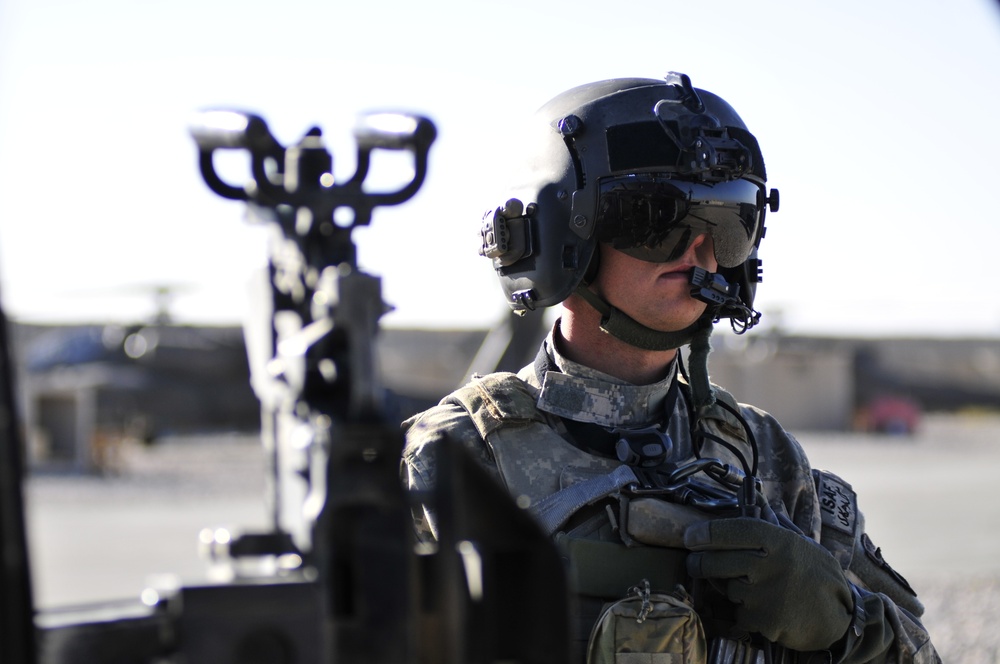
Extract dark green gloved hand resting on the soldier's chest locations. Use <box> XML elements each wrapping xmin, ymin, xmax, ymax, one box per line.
<box><xmin>684</xmin><ymin>517</ymin><xmax>854</xmax><ymax>652</ymax></box>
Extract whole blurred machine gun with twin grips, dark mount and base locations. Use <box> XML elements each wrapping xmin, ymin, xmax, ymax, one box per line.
<box><xmin>0</xmin><ymin>111</ymin><xmax>568</xmax><ymax>664</ymax></box>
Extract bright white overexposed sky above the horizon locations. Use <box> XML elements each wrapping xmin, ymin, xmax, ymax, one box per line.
<box><xmin>0</xmin><ymin>0</ymin><xmax>1000</xmax><ymax>337</ymax></box>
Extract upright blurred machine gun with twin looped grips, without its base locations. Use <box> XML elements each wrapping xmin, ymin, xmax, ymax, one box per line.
<box><xmin>191</xmin><ymin>106</ymin><xmax>436</xmax><ymax>661</ymax></box>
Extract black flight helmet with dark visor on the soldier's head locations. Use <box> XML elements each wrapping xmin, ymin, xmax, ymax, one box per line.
<box><xmin>480</xmin><ymin>73</ymin><xmax>778</xmax><ymax>342</ymax></box>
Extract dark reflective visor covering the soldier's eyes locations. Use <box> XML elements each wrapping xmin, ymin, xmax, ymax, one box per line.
<box><xmin>597</xmin><ymin>179</ymin><xmax>764</xmax><ymax>267</ymax></box>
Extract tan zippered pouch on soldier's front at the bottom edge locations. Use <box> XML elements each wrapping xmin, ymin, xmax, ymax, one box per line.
<box><xmin>587</xmin><ymin>580</ymin><xmax>708</xmax><ymax>664</ymax></box>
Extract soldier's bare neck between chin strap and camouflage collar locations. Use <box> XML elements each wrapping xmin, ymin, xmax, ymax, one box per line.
<box><xmin>559</xmin><ymin>301</ymin><xmax>677</xmax><ymax>385</ymax></box>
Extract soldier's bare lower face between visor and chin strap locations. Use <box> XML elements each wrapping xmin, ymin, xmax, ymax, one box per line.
<box><xmin>591</xmin><ymin>235</ymin><xmax>719</xmax><ymax>332</ymax></box>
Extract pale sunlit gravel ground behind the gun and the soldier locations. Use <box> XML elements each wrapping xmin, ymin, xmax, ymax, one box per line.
<box><xmin>26</xmin><ymin>416</ymin><xmax>1000</xmax><ymax>664</ymax></box>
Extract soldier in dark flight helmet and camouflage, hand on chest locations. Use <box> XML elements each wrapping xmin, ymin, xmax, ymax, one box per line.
<box><xmin>401</xmin><ymin>73</ymin><xmax>939</xmax><ymax>662</ymax></box>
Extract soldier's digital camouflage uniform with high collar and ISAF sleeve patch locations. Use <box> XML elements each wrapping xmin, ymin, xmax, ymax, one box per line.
<box><xmin>401</xmin><ymin>323</ymin><xmax>939</xmax><ymax>662</ymax></box>
